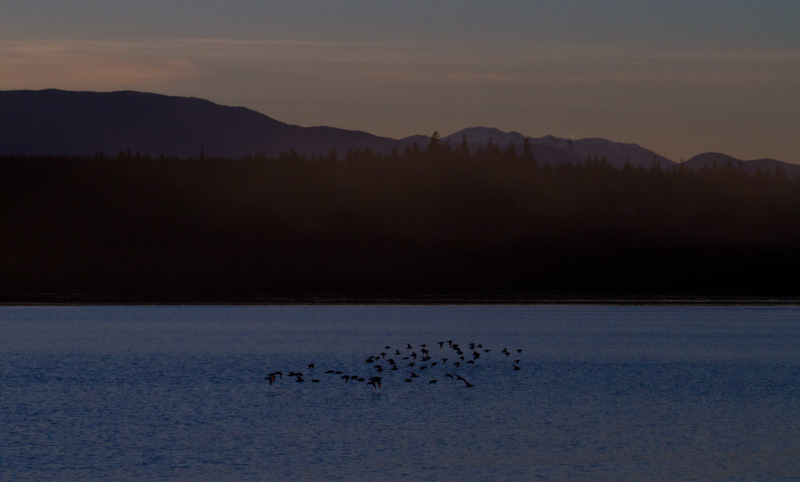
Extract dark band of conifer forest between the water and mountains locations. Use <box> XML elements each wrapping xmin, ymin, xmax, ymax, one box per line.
<box><xmin>0</xmin><ymin>135</ymin><xmax>800</xmax><ymax>301</ymax></box>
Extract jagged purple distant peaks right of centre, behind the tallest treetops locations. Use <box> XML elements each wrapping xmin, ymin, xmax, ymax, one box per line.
<box><xmin>442</xmin><ymin>127</ymin><xmax>674</xmax><ymax>168</ymax></box>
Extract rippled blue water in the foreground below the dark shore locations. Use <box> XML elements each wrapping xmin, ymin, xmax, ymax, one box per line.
<box><xmin>0</xmin><ymin>306</ymin><xmax>800</xmax><ymax>481</ymax></box>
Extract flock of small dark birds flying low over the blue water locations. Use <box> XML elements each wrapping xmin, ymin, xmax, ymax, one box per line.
<box><xmin>264</xmin><ymin>340</ymin><xmax>522</xmax><ymax>390</ymax></box>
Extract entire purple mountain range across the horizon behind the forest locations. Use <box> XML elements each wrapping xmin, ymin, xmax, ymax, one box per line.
<box><xmin>0</xmin><ymin>89</ymin><xmax>800</xmax><ymax>176</ymax></box>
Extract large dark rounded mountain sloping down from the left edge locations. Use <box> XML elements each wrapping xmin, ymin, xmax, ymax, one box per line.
<box><xmin>0</xmin><ymin>90</ymin><xmax>398</xmax><ymax>158</ymax></box>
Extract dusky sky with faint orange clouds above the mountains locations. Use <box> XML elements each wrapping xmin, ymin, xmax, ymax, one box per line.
<box><xmin>0</xmin><ymin>0</ymin><xmax>800</xmax><ymax>163</ymax></box>
